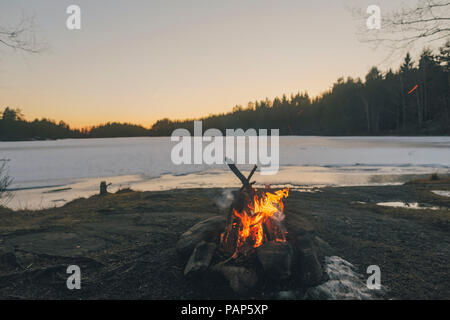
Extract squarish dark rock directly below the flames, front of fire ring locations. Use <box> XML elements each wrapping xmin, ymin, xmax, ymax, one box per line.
<box><xmin>256</xmin><ymin>241</ymin><xmax>293</xmax><ymax>281</ymax></box>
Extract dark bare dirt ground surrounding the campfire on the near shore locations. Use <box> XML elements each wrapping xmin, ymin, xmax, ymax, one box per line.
<box><xmin>0</xmin><ymin>179</ymin><xmax>450</xmax><ymax>299</ymax></box>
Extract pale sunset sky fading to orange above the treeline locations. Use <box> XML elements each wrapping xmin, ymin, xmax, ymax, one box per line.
<box><xmin>0</xmin><ymin>0</ymin><xmax>436</xmax><ymax>127</ymax></box>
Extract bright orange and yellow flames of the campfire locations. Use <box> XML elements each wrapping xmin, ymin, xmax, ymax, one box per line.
<box><xmin>233</xmin><ymin>188</ymin><xmax>289</xmax><ymax>254</ymax></box>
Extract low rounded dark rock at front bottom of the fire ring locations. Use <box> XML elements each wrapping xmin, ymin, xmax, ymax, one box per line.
<box><xmin>212</xmin><ymin>263</ymin><xmax>258</xmax><ymax>295</ymax></box>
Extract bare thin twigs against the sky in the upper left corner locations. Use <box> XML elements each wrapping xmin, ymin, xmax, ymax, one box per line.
<box><xmin>0</xmin><ymin>17</ymin><xmax>46</xmax><ymax>53</ymax></box>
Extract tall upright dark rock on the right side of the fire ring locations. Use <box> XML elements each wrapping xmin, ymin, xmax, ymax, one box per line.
<box><xmin>297</xmin><ymin>233</ymin><xmax>323</xmax><ymax>287</ymax></box>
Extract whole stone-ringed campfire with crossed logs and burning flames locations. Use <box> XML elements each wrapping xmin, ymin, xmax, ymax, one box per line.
<box><xmin>177</xmin><ymin>164</ymin><xmax>331</xmax><ymax>295</ymax></box>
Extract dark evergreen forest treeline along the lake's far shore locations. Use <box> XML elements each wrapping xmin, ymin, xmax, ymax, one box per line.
<box><xmin>0</xmin><ymin>42</ymin><xmax>450</xmax><ymax>140</ymax></box>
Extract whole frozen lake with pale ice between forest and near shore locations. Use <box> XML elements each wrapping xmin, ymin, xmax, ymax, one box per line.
<box><xmin>0</xmin><ymin>137</ymin><xmax>450</xmax><ymax>209</ymax></box>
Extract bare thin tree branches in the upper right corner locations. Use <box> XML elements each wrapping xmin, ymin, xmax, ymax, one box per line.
<box><xmin>352</xmin><ymin>0</ymin><xmax>450</xmax><ymax>52</ymax></box>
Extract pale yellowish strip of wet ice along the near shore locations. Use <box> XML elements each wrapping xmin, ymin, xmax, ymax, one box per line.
<box><xmin>5</xmin><ymin>166</ymin><xmax>450</xmax><ymax>210</ymax></box>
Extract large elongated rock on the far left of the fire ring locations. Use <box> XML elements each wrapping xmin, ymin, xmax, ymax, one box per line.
<box><xmin>177</xmin><ymin>216</ymin><xmax>226</xmax><ymax>257</ymax></box>
